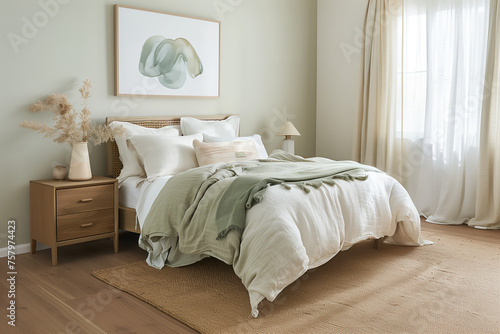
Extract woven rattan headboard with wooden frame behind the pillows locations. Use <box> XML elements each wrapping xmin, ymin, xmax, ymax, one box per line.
<box><xmin>106</xmin><ymin>115</ymin><xmax>233</xmax><ymax>178</ymax></box>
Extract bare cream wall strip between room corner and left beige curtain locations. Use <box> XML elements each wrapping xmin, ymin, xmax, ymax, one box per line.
<box><xmin>316</xmin><ymin>0</ymin><xmax>368</xmax><ymax>160</ymax></box>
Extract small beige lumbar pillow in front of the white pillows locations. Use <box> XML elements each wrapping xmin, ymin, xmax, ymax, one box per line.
<box><xmin>193</xmin><ymin>139</ymin><xmax>259</xmax><ymax>166</ymax></box>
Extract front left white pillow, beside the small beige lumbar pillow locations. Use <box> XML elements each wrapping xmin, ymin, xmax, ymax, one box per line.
<box><xmin>128</xmin><ymin>134</ymin><xmax>203</xmax><ymax>179</ymax></box>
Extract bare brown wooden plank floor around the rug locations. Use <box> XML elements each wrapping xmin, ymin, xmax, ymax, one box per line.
<box><xmin>0</xmin><ymin>222</ymin><xmax>500</xmax><ymax>334</ymax></box>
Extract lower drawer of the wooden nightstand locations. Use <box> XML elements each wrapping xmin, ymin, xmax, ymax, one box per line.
<box><xmin>57</xmin><ymin>209</ymin><xmax>115</xmax><ymax>241</ymax></box>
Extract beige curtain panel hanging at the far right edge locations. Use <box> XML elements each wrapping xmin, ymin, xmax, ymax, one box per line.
<box><xmin>469</xmin><ymin>0</ymin><xmax>500</xmax><ymax>229</ymax></box>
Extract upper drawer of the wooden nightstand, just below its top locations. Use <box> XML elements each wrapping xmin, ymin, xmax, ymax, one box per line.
<box><xmin>57</xmin><ymin>184</ymin><xmax>114</xmax><ymax>215</ymax></box>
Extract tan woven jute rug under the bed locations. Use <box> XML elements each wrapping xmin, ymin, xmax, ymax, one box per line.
<box><xmin>93</xmin><ymin>232</ymin><xmax>500</xmax><ymax>333</ymax></box>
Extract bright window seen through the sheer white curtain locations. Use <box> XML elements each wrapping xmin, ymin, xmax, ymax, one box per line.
<box><xmin>396</xmin><ymin>0</ymin><xmax>489</xmax><ymax>165</ymax></box>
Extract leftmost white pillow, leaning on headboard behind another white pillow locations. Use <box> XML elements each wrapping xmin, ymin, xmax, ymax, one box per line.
<box><xmin>109</xmin><ymin>121</ymin><xmax>180</xmax><ymax>184</ymax></box>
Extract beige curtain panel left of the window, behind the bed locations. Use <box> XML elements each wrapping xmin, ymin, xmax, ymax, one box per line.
<box><xmin>353</xmin><ymin>0</ymin><xmax>402</xmax><ymax>181</ymax></box>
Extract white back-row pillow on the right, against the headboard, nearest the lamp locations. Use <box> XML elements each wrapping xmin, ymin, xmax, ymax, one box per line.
<box><xmin>181</xmin><ymin>116</ymin><xmax>240</xmax><ymax>137</ymax></box>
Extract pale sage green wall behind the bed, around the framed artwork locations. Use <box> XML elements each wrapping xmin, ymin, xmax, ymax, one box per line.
<box><xmin>0</xmin><ymin>0</ymin><xmax>317</xmax><ymax>248</ymax></box>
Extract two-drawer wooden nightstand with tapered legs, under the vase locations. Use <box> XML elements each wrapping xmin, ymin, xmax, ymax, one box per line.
<box><xmin>30</xmin><ymin>176</ymin><xmax>118</xmax><ymax>266</ymax></box>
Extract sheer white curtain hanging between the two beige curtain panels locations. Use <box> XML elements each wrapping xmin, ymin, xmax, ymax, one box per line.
<box><xmin>397</xmin><ymin>0</ymin><xmax>490</xmax><ymax>224</ymax></box>
